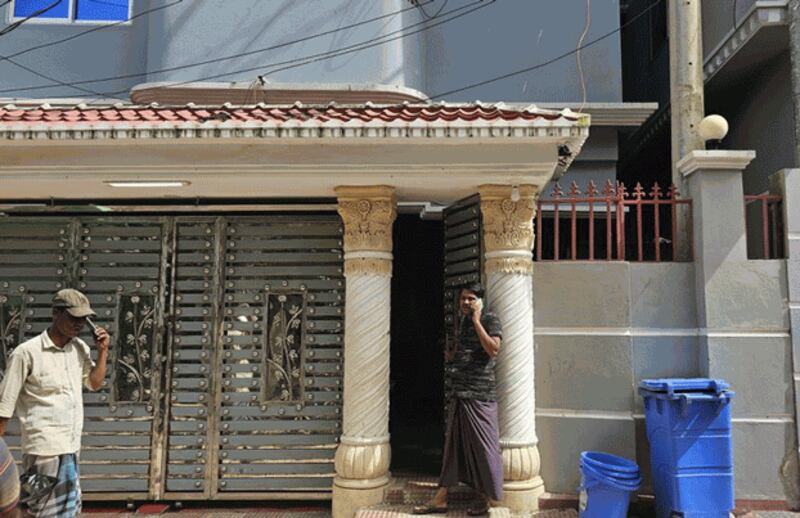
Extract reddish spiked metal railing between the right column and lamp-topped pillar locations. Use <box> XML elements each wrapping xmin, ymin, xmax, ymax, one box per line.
<box><xmin>534</xmin><ymin>180</ymin><xmax>692</xmax><ymax>262</ymax></box>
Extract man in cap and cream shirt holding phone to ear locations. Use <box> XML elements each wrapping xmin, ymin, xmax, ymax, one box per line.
<box><xmin>0</xmin><ymin>289</ymin><xmax>109</xmax><ymax>518</ymax></box>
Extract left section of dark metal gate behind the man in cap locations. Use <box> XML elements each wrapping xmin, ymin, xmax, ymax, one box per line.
<box><xmin>0</xmin><ymin>216</ymin><xmax>170</xmax><ymax>498</ymax></box>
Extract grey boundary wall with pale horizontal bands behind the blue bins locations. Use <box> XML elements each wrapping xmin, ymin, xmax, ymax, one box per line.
<box><xmin>534</xmin><ymin>261</ymin><xmax>793</xmax><ymax>499</ymax></box>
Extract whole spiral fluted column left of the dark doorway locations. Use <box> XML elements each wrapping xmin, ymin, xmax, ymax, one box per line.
<box><xmin>333</xmin><ymin>186</ymin><xmax>396</xmax><ymax>518</ymax></box>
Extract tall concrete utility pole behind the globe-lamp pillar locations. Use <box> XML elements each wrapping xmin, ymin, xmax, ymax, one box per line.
<box><xmin>662</xmin><ymin>0</ymin><xmax>705</xmax><ymax>260</ymax></box>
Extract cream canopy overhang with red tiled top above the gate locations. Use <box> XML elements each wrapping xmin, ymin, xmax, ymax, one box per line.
<box><xmin>0</xmin><ymin>104</ymin><xmax>589</xmax><ymax>204</ymax></box>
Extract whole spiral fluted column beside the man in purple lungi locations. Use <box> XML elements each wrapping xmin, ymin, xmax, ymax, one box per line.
<box><xmin>480</xmin><ymin>185</ymin><xmax>544</xmax><ymax>512</ymax></box>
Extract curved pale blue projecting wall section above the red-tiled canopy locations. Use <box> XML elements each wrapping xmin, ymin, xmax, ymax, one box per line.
<box><xmin>142</xmin><ymin>0</ymin><xmax>424</xmax><ymax>92</ymax></box>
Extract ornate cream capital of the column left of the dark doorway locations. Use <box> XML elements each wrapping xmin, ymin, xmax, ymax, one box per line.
<box><xmin>336</xmin><ymin>185</ymin><xmax>397</xmax><ymax>276</ymax></box>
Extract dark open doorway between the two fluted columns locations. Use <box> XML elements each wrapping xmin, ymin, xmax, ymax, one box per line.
<box><xmin>389</xmin><ymin>215</ymin><xmax>444</xmax><ymax>475</ymax></box>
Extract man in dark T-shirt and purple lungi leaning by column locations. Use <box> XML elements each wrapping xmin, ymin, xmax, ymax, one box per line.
<box><xmin>414</xmin><ymin>284</ymin><xmax>503</xmax><ymax>516</ymax></box>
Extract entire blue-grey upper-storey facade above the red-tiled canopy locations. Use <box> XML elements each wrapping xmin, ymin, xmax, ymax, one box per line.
<box><xmin>0</xmin><ymin>0</ymin><xmax>622</xmax><ymax>102</ymax></box>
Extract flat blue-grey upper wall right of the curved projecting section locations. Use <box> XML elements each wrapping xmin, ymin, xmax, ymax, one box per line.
<box><xmin>423</xmin><ymin>0</ymin><xmax>622</xmax><ymax>102</ymax></box>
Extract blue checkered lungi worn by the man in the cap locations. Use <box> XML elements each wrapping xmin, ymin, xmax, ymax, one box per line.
<box><xmin>20</xmin><ymin>453</ymin><xmax>81</xmax><ymax>518</ymax></box>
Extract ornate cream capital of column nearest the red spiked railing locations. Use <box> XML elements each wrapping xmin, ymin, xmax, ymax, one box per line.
<box><xmin>478</xmin><ymin>185</ymin><xmax>539</xmax><ymax>275</ymax></box>
